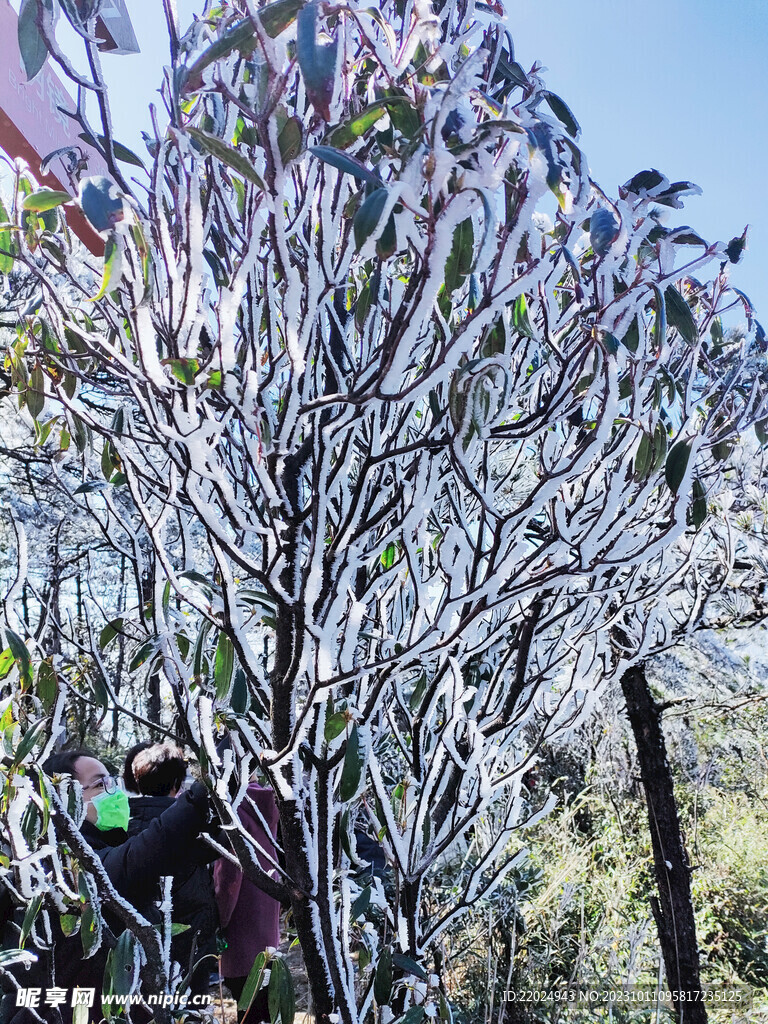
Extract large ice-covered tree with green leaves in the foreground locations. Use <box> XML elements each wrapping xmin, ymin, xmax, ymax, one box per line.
<box><xmin>3</xmin><ymin>0</ymin><xmax>766</xmax><ymax>1024</ymax></box>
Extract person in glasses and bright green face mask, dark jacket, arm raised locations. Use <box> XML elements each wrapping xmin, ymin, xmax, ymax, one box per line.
<box><xmin>0</xmin><ymin>750</ymin><xmax>217</xmax><ymax>1024</ymax></box>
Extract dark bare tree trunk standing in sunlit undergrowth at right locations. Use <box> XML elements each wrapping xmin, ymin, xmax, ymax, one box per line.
<box><xmin>622</xmin><ymin>666</ymin><xmax>707</xmax><ymax>1024</ymax></box>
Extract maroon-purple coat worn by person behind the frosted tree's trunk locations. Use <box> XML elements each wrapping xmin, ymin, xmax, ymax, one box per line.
<box><xmin>213</xmin><ymin>782</ymin><xmax>280</xmax><ymax>978</ymax></box>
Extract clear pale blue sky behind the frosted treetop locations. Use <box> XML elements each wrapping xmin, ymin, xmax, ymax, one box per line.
<box><xmin>94</xmin><ymin>0</ymin><xmax>768</xmax><ymax>311</ymax></box>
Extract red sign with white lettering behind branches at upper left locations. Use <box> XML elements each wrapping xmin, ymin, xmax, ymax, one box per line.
<box><xmin>0</xmin><ymin>0</ymin><xmax>109</xmax><ymax>255</ymax></box>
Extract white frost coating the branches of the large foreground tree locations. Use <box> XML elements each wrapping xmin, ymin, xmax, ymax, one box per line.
<box><xmin>3</xmin><ymin>0</ymin><xmax>765</xmax><ymax>1024</ymax></box>
